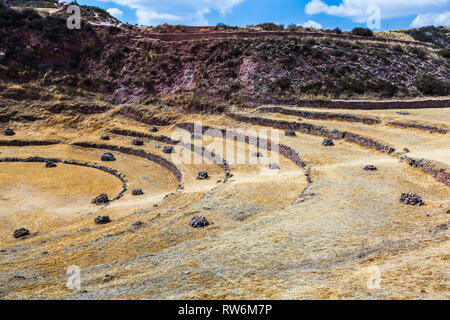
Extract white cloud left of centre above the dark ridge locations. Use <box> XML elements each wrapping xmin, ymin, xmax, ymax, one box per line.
<box><xmin>101</xmin><ymin>0</ymin><xmax>245</xmax><ymax>25</ymax></box>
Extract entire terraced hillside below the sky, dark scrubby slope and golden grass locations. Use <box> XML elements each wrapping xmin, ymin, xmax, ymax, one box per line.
<box><xmin>0</xmin><ymin>1</ymin><xmax>450</xmax><ymax>299</ymax></box>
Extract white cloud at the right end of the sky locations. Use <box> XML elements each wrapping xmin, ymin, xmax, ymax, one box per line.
<box><xmin>305</xmin><ymin>0</ymin><xmax>450</xmax><ymax>23</ymax></box>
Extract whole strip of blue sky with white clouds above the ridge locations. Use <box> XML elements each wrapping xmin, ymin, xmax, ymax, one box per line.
<box><xmin>78</xmin><ymin>0</ymin><xmax>450</xmax><ymax>30</ymax></box>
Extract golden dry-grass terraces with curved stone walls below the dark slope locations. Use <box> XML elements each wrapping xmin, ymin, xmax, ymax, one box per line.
<box><xmin>0</xmin><ymin>101</ymin><xmax>450</xmax><ymax>299</ymax></box>
